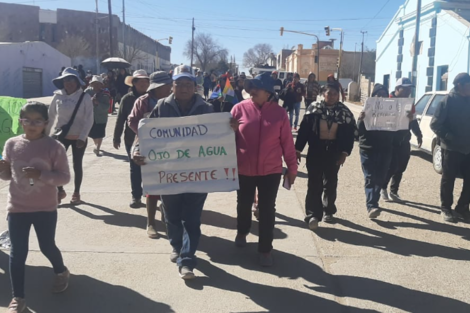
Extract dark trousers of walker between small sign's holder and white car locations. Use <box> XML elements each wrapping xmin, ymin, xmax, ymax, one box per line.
<box><xmin>382</xmin><ymin>141</ymin><xmax>411</xmax><ymax>193</ymax></box>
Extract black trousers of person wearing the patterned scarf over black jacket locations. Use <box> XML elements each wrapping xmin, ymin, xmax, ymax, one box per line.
<box><xmin>305</xmin><ymin>146</ymin><xmax>339</xmax><ymax>223</ymax></box>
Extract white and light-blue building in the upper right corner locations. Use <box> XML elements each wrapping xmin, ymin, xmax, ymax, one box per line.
<box><xmin>375</xmin><ymin>0</ymin><xmax>470</xmax><ymax>98</ymax></box>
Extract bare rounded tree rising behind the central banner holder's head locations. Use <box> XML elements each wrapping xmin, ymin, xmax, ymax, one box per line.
<box><xmin>183</xmin><ymin>33</ymin><xmax>228</xmax><ymax>71</ymax></box>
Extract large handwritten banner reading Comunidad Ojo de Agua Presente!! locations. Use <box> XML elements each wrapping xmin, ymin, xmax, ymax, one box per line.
<box><xmin>139</xmin><ymin>113</ymin><xmax>239</xmax><ymax>195</ymax></box>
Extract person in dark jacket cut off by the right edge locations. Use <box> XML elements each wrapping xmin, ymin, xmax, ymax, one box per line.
<box><xmin>431</xmin><ymin>73</ymin><xmax>470</xmax><ymax>222</ymax></box>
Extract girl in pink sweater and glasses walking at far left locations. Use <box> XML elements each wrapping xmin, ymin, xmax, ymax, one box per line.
<box><xmin>0</xmin><ymin>102</ymin><xmax>70</xmax><ymax>313</ymax></box>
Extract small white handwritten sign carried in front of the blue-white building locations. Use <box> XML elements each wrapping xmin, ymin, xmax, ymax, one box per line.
<box><xmin>364</xmin><ymin>97</ymin><xmax>414</xmax><ymax>131</ymax></box>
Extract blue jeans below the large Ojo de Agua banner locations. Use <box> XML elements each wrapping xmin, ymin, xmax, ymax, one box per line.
<box><xmin>162</xmin><ymin>193</ymin><xmax>207</xmax><ymax>269</ymax></box>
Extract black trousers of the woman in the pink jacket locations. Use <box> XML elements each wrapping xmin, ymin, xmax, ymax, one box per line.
<box><xmin>237</xmin><ymin>174</ymin><xmax>281</xmax><ymax>253</ymax></box>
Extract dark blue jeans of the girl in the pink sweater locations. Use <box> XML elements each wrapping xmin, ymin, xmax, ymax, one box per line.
<box><xmin>8</xmin><ymin>211</ymin><xmax>65</xmax><ymax>298</ymax></box>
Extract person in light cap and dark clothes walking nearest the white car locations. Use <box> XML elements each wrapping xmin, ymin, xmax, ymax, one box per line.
<box><xmin>381</xmin><ymin>77</ymin><xmax>423</xmax><ymax>202</ymax></box>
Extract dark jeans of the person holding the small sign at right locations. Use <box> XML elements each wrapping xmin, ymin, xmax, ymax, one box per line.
<box><xmin>359</xmin><ymin>149</ymin><xmax>392</xmax><ymax>211</ymax></box>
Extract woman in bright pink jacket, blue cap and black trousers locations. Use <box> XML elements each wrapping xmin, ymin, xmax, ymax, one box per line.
<box><xmin>232</xmin><ymin>73</ymin><xmax>297</xmax><ymax>266</ymax></box>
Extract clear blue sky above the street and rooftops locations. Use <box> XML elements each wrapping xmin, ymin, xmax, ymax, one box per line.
<box><xmin>8</xmin><ymin>0</ymin><xmax>405</xmax><ymax>70</ymax></box>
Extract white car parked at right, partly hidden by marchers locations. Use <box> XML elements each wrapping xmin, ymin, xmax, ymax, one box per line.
<box><xmin>411</xmin><ymin>91</ymin><xmax>447</xmax><ymax>174</ymax></box>
